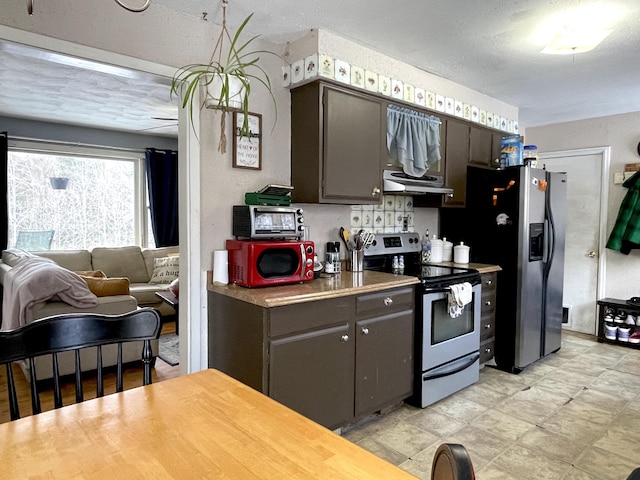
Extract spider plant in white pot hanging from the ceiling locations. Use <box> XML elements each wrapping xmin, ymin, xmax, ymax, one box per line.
<box><xmin>171</xmin><ymin>8</ymin><xmax>280</xmax><ymax>153</ymax></box>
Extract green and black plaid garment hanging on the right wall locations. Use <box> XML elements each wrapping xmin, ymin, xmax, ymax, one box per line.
<box><xmin>607</xmin><ymin>172</ymin><xmax>640</xmax><ymax>255</ymax></box>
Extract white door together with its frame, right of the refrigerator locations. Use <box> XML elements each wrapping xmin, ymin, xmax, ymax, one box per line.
<box><xmin>540</xmin><ymin>147</ymin><xmax>610</xmax><ymax>335</ymax></box>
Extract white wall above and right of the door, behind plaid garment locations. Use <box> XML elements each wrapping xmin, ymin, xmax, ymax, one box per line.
<box><xmin>525</xmin><ymin>113</ymin><xmax>640</xmax><ymax>299</ymax></box>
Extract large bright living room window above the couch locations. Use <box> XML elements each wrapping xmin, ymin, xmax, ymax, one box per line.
<box><xmin>7</xmin><ymin>139</ymin><xmax>155</xmax><ymax>250</ymax></box>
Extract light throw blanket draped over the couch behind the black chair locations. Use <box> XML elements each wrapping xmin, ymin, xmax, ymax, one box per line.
<box><xmin>2</xmin><ymin>257</ymin><xmax>98</xmax><ymax>330</ymax></box>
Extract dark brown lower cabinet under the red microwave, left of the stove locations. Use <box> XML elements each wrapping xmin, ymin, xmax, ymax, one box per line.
<box><xmin>209</xmin><ymin>287</ymin><xmax>414</xmax><ymax>428</ymax></box>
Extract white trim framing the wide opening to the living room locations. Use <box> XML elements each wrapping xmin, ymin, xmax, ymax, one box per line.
<box><xmin>0</xmin><ymin>25</ymin><xmax>208</xmax><ymax>375</ymax></box>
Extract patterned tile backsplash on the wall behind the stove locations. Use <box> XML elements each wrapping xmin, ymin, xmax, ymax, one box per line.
<box><xmin>349</xmin><ymin>195</ymin><xmax>415</xmax><ymax>233</ymax></box>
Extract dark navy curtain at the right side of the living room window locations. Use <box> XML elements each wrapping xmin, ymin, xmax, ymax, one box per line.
<box><xmin>146</xmin><ymin>148</ymin><xmax>179</xmax><ymax>247</ymax></box>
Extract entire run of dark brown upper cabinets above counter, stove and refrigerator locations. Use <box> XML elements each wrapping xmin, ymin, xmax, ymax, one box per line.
<box><xmin>291</xmin><ymin>81</ymin><xmax>504</xmax><ymax>208</ymax></box>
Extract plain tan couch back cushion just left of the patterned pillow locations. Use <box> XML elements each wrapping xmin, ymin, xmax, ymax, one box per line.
<box><xmin>91</xmin><ymin>246</ymin><xmax>149</xmax><ymax>283</ymax></box>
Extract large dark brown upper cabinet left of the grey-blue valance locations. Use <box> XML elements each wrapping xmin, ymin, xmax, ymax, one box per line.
<box><xmin>291</xmin><ymin>82</ymin><xmax>386</xmax><ymax>204</ymax></box>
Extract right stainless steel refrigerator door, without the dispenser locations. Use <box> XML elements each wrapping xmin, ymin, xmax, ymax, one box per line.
<box><xmin>543</xmin><ymin>172</ymin><xmax>567</xmax><ymax>355</ymax></box>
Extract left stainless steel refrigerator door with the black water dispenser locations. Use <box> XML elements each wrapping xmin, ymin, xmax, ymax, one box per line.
<box><xmin>514</xmin><ymin>168</ymin><xmax>546</xmax><ymax>369</ymax></box>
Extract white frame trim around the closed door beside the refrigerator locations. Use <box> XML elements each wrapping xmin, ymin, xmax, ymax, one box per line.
<box><xmin>538</xmin><ymin>146</ymin><xmax>611</xmax><ymax>332</ymax></box>
